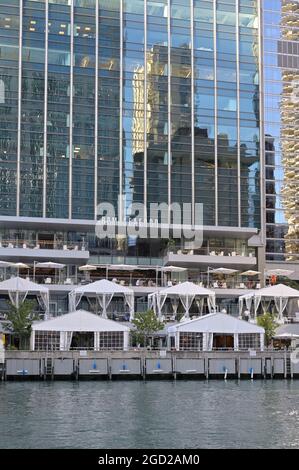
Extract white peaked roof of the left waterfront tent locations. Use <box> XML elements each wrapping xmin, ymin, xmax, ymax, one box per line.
<box><xmin>32</xmin><ymin>310</ymin><xmax>130</xmax><ymax>332</ymax></box>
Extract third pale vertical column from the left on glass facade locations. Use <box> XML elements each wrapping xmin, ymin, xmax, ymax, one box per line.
<box><xmin>69</xmin><ymin>1</ymin><xmax>74</xmax><ymax>219</ymax></box>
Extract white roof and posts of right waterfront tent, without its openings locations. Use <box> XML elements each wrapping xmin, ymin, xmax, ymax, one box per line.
<box><xmin>167</xmin><ymin>313</ymin><xmax>265</xmax><ymax>351</ymax></box>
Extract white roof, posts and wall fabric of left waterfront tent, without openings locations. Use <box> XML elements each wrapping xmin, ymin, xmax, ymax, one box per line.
<box><xmin>31</xmin><ymin>310</ymin><xmax>130</xmax><ymax>351</ymax></box>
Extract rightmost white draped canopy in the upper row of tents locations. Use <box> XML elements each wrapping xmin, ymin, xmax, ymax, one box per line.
<box><xmin>239</xmin><ymin>284</ymin><xmax>299</xmax><ymax>321</ymax></box>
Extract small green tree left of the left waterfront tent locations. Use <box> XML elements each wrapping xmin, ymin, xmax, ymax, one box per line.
<box><xmin>6</xmin><ymin>300</ymin><xmax>39</xmax><ymax>349</ymax></box>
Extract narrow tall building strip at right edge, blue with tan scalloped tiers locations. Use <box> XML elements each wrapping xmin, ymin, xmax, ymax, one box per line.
<box><xmin>263</xmin><ymin>0</ymin><xmax>299</xmax><ymax>279</ymax></box>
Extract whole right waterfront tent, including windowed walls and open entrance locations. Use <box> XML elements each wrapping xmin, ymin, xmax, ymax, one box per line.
<box><xmin>167</xmin><ymin>313</ymin><xmax>265</xmax><ymax>351</ymax></box>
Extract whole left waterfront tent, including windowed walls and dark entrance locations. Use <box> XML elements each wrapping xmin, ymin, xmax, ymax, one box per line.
<box><xmin>30</xmin><ymin>310</ymin><xmax>130</xmax><ymax>351</ymax></box>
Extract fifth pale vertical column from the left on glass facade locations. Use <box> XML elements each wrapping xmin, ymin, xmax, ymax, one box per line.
<box><xmin>118</xmin><ymin>0</ymin><xmax>124</xmax><ymax>221</ymax></box>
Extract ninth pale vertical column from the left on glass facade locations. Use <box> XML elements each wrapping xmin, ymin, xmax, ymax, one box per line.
<box><xmin>213</xmin><ymin>0</ymin><xmax>218</xmax><ymax>225</ymax></box>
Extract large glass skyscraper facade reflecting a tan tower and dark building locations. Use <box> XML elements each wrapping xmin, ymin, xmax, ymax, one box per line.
<box><xmin>0</xmin><ymin>0</ymin><xmax>262</xmax><ymax>228</ymax></box>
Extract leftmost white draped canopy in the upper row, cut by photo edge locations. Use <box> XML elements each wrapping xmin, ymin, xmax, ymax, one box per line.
<box><xmin>0</xmin><ymin>277</ymin><xmax>49</xmax><ymax>318</ymax></box>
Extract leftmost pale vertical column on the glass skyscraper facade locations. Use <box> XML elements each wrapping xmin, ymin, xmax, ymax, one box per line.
<box><xmin>16</xmin><ymin>0</ymin><xmax>23</xmax><ymax>216</ymax></box>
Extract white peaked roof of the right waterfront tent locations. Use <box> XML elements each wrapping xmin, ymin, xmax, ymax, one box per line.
<box><xmin>168</xmin><ymin>313</ymin><xmax>265</xmax><ymax>334</ymax></box>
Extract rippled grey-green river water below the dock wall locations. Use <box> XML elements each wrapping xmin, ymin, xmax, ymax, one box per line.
<box><xmin>0</xmin><ymin>380</ymin><xmax>299</xmax><ymax>449</ymax></box>
